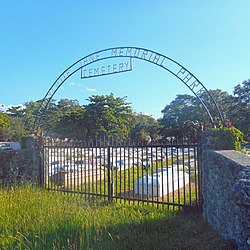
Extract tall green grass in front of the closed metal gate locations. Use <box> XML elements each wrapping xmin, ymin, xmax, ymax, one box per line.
<box><xmin>0</xmin><ymin>186</ymin><xmax>235</xmax><ymax>250</ymax></box>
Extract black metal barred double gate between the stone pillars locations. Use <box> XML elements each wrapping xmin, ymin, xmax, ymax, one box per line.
<box><xmin>43</xmin><ymin>139</ymin><xmax>201</xmax><ymax>208</ymax></box>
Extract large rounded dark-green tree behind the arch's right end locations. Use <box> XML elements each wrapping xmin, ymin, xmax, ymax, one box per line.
<box><xmin>160</xmin><ymin>89</ymin><xmax>236</xmax><ymax>138</ymax></box>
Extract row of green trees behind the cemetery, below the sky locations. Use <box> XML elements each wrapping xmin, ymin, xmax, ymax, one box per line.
<box><xmin>0</xmin><ymin>80</ymin><xmax>250</xmax><ymax>141</ymax></box>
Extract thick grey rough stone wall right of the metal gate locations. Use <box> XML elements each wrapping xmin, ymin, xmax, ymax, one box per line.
<box><xmin>202</xmin><ymin>130</ymin><xmax>250</xmax><ymax>249</ymax></box>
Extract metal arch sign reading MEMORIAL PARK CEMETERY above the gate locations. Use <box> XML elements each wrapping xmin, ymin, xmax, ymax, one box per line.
<box><xmin>34</xmin><ymin>47</ymin><xmax>224</xmax><ymax>131</ymax></box>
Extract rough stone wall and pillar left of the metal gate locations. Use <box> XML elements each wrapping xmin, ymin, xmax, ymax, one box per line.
<box><xmin>0</xmin><ymin>137</ymin><xmax>40</xmax><ymax>186</ymax></box>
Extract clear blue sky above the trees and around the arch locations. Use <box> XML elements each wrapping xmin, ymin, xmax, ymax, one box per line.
<box><xmin>0</xmin><ymin>0</ymin><xmax>250</xmax><ymax>118</ymax></box>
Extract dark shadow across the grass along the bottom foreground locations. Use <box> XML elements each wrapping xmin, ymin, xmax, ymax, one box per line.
<box><xmin>7</xmin><ymin>212</ymin><xmax>237</xmax><ymax>250</ymax></box>
